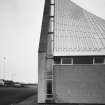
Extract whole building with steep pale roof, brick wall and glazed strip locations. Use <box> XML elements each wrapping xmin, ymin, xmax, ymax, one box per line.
<box><xmin>38</xmin><ymin>0</ymin><xmax>105</xmax><ymax>104</ymax></box>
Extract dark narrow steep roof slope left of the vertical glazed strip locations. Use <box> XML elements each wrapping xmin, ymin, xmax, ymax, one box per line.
<box><xmin>38</xmin><ymin>0</ymin><xmax>50</xmax><ymax>53</ymax></box>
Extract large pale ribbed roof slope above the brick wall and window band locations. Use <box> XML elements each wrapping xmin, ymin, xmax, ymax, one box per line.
<box><xmin>54</xmin><ymin>0</ymin><xmax>105</xmax><ymax>56</ymax></box>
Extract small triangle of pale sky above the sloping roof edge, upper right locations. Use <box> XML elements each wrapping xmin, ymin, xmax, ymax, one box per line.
<box><xmin>71</xmin><ymin>0</ymin><xmax>105</xmax><ymax>19</ymax></box>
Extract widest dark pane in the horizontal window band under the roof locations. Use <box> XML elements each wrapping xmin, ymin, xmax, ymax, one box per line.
<box><xmin>73</xmin><ymin>56</ymin><xmax>93</xmax><ymax>64</ymax></box>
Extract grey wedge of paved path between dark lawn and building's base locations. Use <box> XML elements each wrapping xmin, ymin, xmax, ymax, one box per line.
<box><xmin>15</xmin><ymin>95</ymin><xmax>37</xmax><ymax>105</ymax></box>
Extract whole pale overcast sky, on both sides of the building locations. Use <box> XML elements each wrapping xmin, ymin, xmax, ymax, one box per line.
<box><xmin>0</xmin><ymin>0</ymin><xmax>105</xmax><ymax>83</ymax></box>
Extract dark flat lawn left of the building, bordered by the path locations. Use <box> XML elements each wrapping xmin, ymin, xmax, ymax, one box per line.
<box><xmin>0</xmin><ymin>87</ymin><xmax>37</xmax><ymax>105</ymax></box>
